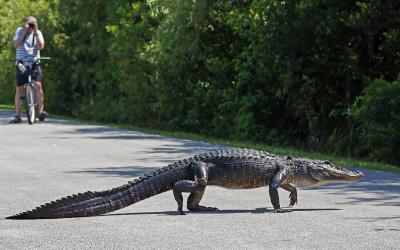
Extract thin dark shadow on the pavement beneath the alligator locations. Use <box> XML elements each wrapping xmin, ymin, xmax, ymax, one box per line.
<box><xmin>100</xmin><ymin>208</ymin><xmax>342</xmax><ymax>216</ymax></box>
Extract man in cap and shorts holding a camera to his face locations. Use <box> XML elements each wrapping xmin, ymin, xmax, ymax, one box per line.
<box><xmin>10</xmin><ymin>16</ymin><xmax>47</xmax><ymax>123</ymax></box>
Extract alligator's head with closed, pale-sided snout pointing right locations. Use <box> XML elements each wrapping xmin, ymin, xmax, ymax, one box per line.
<box><xmin>293</xmin><ymin>158</ymin><xmax>364</xmax><ymax>186</ymax></box>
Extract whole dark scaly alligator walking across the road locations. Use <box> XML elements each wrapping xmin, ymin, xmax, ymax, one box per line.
<box><xmin>7</xmin><ymin>148</ymin><xmax>363</xmax><ymax>219</ymax></box>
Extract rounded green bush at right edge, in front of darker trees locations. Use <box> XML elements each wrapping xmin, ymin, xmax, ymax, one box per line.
<box><xmin>352</xmin><ymin>78</ymin><xmax>400</xmax><ymax>164</ymax></box>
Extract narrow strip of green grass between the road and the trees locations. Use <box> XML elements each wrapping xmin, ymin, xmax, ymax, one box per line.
<box><xmin>0</xmin><ymin>104</ymin><xmax>400</xmax><ymax>174</ymax></box>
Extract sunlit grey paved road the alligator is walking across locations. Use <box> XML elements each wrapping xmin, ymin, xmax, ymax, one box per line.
<box><xmin>0</xmin><ymin>111</ymin><xmax>400</xmax><ymax>249</ymax></box>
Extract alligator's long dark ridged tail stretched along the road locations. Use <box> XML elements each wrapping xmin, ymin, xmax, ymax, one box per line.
<box><xmin>6</xmin><ymin>162</ymin><xmax>188</xmax><ymax>219</ymax></box>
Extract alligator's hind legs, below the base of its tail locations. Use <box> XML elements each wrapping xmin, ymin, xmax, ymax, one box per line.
<box><xmin>173</xmin><ymin>162</ymin><xmax>218</xmax><ymax>215</ymax></box>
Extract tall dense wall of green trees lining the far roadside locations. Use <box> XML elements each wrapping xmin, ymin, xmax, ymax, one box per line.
<box><xmin>0</xmin><ymin>0</ymin><xmax>400</xmax><ymax>165</ymax></box>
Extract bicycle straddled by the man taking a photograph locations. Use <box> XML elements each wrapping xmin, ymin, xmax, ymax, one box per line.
<box><xmin>17</xmin><ymin>57</ymin><xmax>51</xmax><ymax>125</ymax></box>
